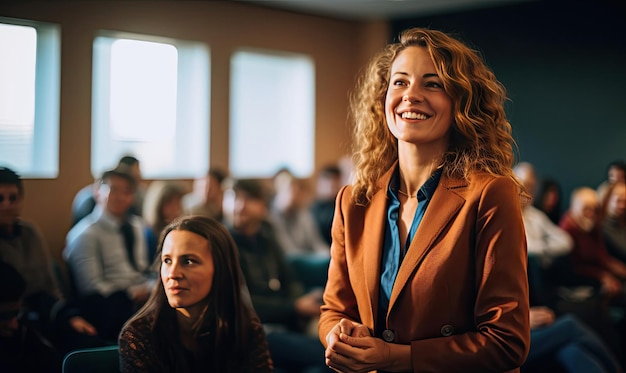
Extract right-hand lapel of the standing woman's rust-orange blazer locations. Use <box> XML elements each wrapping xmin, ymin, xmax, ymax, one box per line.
<box><xmin>389</xmin><ymin>176</ymin><xmax>467</xmax><ymax>311</ymax></box>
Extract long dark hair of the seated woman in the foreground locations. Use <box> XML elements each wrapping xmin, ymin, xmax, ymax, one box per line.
<box><xmin>123</xmin><ymin>216</ymin><xmax>258</xmax><ymax>372</ymax></box>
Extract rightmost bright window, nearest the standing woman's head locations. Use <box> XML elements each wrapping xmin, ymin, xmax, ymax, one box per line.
<box><xmin>230</xmin><ymin>50</ymin><xmax>315</xmax><ymax>177</ymax></box>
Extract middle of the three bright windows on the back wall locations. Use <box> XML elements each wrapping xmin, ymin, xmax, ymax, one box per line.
<box><xmin>91</xmin><ymin>32</ymin><xmax>209</xmax><ymax>178</ymax></box>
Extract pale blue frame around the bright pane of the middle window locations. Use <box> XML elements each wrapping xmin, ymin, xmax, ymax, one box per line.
<box><xmin>91</xmin><ymin>31</ymin><xmax>210</xmax><ymax>179</ymax></box>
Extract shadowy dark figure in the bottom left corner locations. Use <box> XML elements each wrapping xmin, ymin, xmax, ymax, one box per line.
<box><xmin>0</xmin><ymin>261</ymin><xmax>62</xmax><ymax>373</ymax></box>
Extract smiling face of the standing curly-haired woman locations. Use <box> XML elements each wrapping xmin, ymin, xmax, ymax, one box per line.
<box><xmin>385</xmin><ymin>47</ymin><xmax>452</xmax><ymax>150</ymax></box>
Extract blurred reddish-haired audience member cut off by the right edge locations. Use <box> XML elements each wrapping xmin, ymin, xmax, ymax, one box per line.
<box><xmin>602</xmin><ymin>182</ymin><xmax>626</xmax><ymax>263</ymax></box>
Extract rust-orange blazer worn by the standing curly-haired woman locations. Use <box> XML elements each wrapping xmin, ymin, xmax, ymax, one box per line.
<box><xmin>319</xmin><ymin>166</ymin><xmax>530</xmax><ymax>373</ymax></box>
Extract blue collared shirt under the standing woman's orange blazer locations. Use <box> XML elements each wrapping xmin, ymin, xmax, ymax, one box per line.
<box><xmin>377</xmin><ymin>168</ymin><xmax>443</xmax><ymax>329</ymax></box>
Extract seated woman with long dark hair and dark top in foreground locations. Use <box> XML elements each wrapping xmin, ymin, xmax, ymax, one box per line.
<box><xmin>119</xmin><ymin>216</ymin><xmax>273</xmax><ymax>372</ymax></box>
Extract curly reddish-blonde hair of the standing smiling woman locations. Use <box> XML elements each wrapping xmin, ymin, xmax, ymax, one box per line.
<box><xmin>350</xmin><ymin>28</ymin><xmax>519</xmax><ymax>204</ymax></box>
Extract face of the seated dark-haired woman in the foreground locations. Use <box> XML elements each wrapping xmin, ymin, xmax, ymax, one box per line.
<box><xmin>161</xmin><ymin>230</ymin><xmax>215</xmax><ymax>313</ymax></box>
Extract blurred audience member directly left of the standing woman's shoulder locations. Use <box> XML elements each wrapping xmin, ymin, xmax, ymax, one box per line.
<box><xmin>311</xmin><ymin>165</ymin><xmax>343</xmax><ymax>246</ymax></box>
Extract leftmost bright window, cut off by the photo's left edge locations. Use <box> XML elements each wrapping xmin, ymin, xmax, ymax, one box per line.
<box><xmin>0</xmin><ymin>17</ymin><xmax>61</xmax><ymax>178</ymax></box>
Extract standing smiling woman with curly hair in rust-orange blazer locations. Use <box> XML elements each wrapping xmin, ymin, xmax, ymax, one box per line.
<box><xmin>319</xmin><ymin>28</ymin><xmax>530</xmax><ymax>372</ymax></box>
